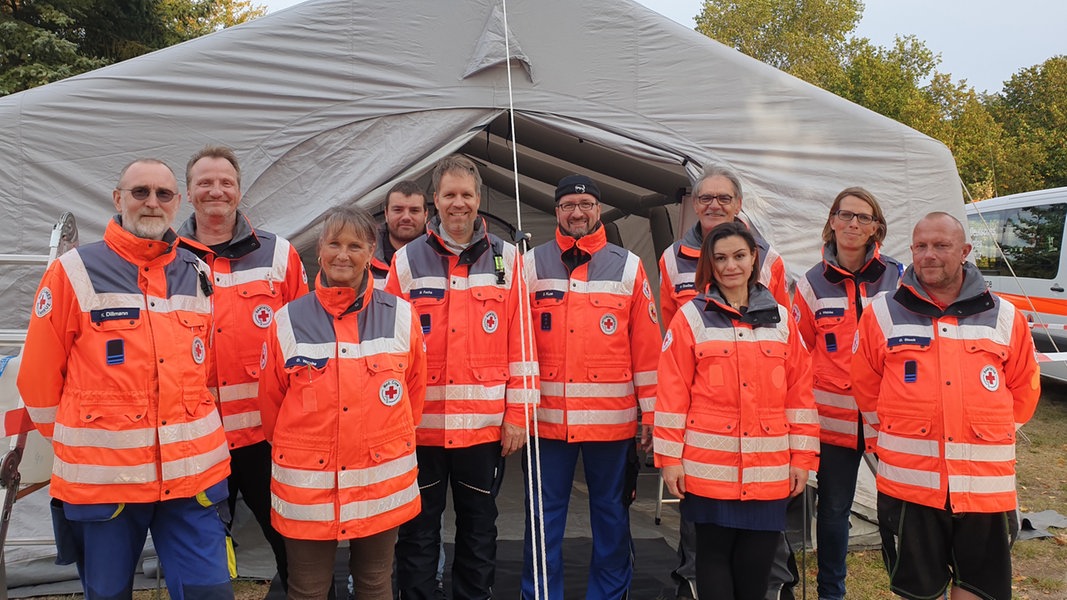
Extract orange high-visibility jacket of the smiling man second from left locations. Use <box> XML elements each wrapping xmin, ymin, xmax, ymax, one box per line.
<box><xmin>178</xmin><ymin>211</ymin><xmax>307</xmax><ymax>448</ymax></box>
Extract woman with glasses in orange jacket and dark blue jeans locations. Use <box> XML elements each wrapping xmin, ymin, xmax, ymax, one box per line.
<box><xmin>793</xmin><ymin>187</ymin><xmax>904</xmax><ymax>600</ymax></box>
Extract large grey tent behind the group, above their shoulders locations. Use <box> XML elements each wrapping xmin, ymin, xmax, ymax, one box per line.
<box><xmin>0</xmin><ymin>0</ymin><xmax>962</xmax><ymax>337</ymax></box>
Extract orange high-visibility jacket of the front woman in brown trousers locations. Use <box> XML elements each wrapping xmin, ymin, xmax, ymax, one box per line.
<box><xmin>259</xmin><ymin>277</ymin><xmax>426</xmax><ymax>540</ymax></box>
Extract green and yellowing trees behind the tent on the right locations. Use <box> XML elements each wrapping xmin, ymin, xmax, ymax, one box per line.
<box><xmin>697</xmin><ymin>0</ymin><xmax>1067</xmax><ymax>200</ymax></box>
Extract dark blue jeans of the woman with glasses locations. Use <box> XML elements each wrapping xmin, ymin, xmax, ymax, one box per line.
<box><xmin>815</xmin><ymin>443</ymin><xmax>863</xmax><ymax>600</ymax></box>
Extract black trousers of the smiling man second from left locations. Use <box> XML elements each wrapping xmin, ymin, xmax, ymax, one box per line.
<box><xmin>226</xmin><ymin>441</ymin><xmax>289</xmax><ymax>589</ymax></box>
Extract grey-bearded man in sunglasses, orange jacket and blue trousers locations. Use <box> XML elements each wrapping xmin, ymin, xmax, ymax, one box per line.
<box><xmin>18</xmin><ymin>159</ymin><xmax>234</xmax><ymax>599</ymax></box>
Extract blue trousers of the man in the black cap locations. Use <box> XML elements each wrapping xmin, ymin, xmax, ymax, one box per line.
<box><xmin>522</xmin><ymin>439</ymin><xmax>634</xmax><ymax>600</ymax></box>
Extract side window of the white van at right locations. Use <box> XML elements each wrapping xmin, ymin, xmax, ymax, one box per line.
<box><xmin>967</xmin><ymin>204</ymin><xmax>1067</xmax><ymax>279</ymax></box>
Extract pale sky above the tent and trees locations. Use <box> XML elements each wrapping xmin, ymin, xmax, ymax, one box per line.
<box><xmin>253</xmin><ymin>0</ymin><xmax>1067</xmax><ymax>93</ymax></box>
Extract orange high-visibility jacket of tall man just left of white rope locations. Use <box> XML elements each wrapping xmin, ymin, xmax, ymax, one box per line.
<box><xmin>385</xmin><ymin>218</ymin><xmax>538</xmax><ymax>448</ymax></box>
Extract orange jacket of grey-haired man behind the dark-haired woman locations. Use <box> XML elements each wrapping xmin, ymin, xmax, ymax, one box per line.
<box><xmin>659</xmin><ymin>222</ymin><xmax>790</xmax><ymax>327</ymax></box>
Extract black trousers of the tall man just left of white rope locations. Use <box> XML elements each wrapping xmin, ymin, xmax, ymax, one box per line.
<box><xmin>397</xmin><ymin>442</ymin><xmax>504</xmax><ymax>600</ymax></box>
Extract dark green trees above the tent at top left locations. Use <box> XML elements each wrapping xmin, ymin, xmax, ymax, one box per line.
<box><xmin>0</xmin><ymin>0</ymin><xmax>267</xmax><ymax>96</ymax></box>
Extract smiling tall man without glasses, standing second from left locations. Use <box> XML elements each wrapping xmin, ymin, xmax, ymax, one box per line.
<box><xmin>178</xmin><ymin>145</ymin><xmax>307</xmax><ymax>589</ymax></box>
